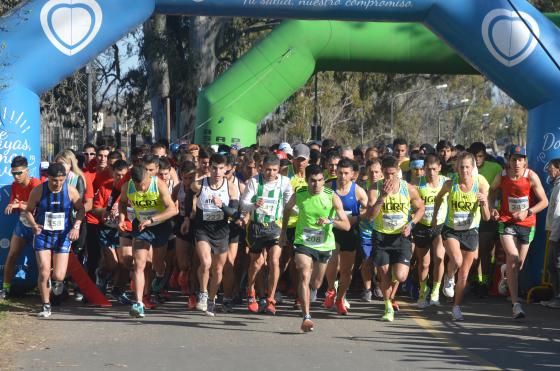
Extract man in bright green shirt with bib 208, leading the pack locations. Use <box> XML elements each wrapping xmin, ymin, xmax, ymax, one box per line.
<box><xmin>280</xmin><ymin>164</ymin><xmax>350</xmax><ymax>332</ymax></box>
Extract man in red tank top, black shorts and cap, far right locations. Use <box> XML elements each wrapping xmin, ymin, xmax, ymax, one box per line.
<box><xmin>490</xmin><ymin>145</ymin><xmax>548</xmax><ymax>318</ymax></box>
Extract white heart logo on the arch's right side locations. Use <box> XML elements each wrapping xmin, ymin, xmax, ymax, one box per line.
<box><xmin>482</xmin><ymin>9</ymin><xmax>540</xmax><ymax>67</ymax></box>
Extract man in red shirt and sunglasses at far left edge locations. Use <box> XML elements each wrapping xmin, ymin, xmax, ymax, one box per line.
<box><xmin>0</xmin><ymin>156</ymin><xmax>41</xmax><ymax>300</ymax></box>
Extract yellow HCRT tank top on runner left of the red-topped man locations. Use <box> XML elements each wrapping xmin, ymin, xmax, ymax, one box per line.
<box><xmin>445</xmin><ymin>175</ymin><xmax>482</xmax><ymax>231</ymax></box>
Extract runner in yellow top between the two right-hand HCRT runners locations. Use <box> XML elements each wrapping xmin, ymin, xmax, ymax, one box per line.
<box><xmin>412</xmin><ymin>155</ymin><xmax>447</xmax><ymax>309</ymax></box>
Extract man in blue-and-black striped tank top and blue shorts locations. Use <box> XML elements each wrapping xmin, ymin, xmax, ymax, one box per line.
<box><xmin>25</xmin><ymin>163</ymin><xmax>85</xmax><ymax>318</ymax></box>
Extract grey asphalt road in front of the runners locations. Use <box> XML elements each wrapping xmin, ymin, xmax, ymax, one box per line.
<box><xmin>9</xmin><ymin>297</ymin><xmax>560</xmax><ymax>371</ymax></box>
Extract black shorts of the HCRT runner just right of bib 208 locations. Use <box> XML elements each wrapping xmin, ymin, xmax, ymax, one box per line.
<box><xmin>371</xmin><ymin>231</ymin><xmax>412</xmax><ymax>267</ymax></box>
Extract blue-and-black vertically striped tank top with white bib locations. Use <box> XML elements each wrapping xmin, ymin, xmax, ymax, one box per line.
<box><xmin>36</xmin><ymin>182</ymin><xmax>74</xmax><ymax>241</ymax></box>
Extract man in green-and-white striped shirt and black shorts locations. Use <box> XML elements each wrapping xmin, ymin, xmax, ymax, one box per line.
<box><xmin>241</xmin><ymin>154</ymin><xmax>292</xmax><ymax>315</ymax></box>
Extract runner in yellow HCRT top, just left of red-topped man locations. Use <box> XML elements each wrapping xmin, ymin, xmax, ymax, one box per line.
<box><xmin>432</xmin><ymin>152</ymin><xmax>490</xmax><ymax>321</ymax></box>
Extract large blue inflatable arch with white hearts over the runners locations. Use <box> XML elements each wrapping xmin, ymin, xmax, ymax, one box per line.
<box><xmin>0</xmin><ymin>0</ymin><xmax>560</xmax><ymax>283</ymax></box>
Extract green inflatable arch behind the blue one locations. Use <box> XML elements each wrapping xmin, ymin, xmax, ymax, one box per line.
<box><xmin>195</xmin><ymin>14</ymin><xmax>560</xmax><ymax>147</ymax></box>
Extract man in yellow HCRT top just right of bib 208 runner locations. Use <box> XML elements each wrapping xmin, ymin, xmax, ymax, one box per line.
<box><xmin>367</xmin><ymin>156</ymin><xmax>424</xmax><ymax>322</ymax></box>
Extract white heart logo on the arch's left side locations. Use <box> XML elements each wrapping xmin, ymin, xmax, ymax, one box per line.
<box><xmin>41</xmin><ymin>0</ymin><xmax>103</xmax><ymax>56</ymax></box>
